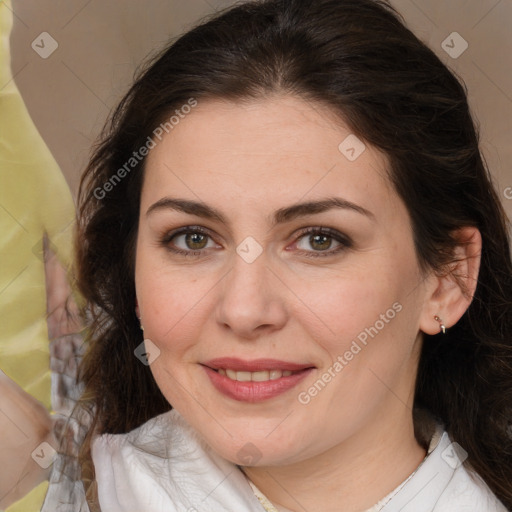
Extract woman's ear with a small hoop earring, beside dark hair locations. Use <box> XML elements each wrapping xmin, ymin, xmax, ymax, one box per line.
<box><xmin>419</xmin><ymin>227</ymin><xmax>482</xmax><ymax>334</ymax></box>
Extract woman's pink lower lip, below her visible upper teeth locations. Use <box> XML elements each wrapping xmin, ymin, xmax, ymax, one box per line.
<box><xmin>203</xmin><ymin>366</ymin><xmax>314</xmax><ymax>403</ymax></box>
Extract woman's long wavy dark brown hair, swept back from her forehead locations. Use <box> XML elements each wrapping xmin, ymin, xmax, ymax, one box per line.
<box><xmin>76</xmin><ymin>0</ymin><xmax>512</xmax><ymax>507</ymax></box>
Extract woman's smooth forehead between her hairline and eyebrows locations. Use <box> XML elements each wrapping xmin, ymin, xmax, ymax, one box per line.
<box><xmin>142</xmin><ymin>96</ymin><xmax>398</xmax><ymax>219</ymax></box>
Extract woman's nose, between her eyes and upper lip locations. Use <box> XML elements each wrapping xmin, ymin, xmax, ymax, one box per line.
<box><xmin>216</xmin><ymin>254</ymin><xmax>288</xmax><ymax>339</ymax></box>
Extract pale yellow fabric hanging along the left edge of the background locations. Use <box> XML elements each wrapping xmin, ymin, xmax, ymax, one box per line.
<box><xmin>0</xmin><ymin>0</ymin><xmax>74</xmax><ymax>512</ymax></box>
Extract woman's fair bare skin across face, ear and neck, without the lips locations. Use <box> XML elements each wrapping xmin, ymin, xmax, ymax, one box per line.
<box><xmin>135</xmin><ymin>94</ymin><xmax>481</xmax><ymax>512</ymax></box>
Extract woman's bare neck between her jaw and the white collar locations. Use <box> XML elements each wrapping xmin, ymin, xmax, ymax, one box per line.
<box><xmin>244</xmin><ymin>404</ymin><xmax>426</xmax><ymax>512</ymax></box>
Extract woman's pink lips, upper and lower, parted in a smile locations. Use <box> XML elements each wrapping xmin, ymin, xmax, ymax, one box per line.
<box><xmin>202</xmin><ymin>357</ymin><xmax>314</xmax><ymax>403</ymax></box>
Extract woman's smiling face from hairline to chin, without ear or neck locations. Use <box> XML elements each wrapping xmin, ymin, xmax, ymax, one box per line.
<box><xmin>135</xmin><ymin>96</ymin><xmax>432</xmax><ymax>465</ymax></box>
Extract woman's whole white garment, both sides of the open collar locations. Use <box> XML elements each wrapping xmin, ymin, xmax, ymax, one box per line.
<box><xmin>92</xmin><ymin>410</ymin><xmax>507</xmax><ymax>512</ymax></box>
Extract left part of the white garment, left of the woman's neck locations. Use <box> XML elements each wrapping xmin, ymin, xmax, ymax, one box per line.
<box><xmin>92</xmin><ymin>409</ymin><xmax>264</xmax><ymax>512</ymax></box>
